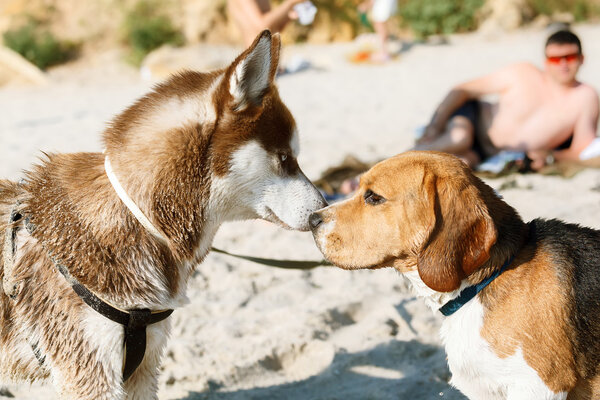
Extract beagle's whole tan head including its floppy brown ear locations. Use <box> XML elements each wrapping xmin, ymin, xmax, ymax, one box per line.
<box><xmin>310</xmin><ymin>152</ymin><xmax>501</xmax><ymax>291</ymax></box>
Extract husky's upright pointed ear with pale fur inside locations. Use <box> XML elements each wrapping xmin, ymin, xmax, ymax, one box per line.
<box><xmin>229</xmin><ymin>30</ymin><xmax>281</xmax><ymax>110</ymax></box>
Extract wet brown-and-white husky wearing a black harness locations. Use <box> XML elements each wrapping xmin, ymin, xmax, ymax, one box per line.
<box><xmin>0</xmin><ymin>31</ymin><xmax>326</xmax><ymax>400</ymax></box>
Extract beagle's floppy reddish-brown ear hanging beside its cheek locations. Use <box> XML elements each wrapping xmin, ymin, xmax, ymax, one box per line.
<box><xmin>417</xmin><ymin>174</ymin><xmax>497</xmax><ymax>292</ymax></box>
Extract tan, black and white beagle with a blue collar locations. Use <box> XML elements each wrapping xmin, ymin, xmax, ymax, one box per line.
<box><xmin>310</xmin><ymin>151</ymin><xmax>600</xmax><ymax>400</ymax></box>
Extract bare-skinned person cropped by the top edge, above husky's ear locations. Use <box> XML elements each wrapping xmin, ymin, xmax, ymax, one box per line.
<box><xmin>227</xmin><ymin>0</ymin><xmax>305</xmax><ymax>46</ymax></box>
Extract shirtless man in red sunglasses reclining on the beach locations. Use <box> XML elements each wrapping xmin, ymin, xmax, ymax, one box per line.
<box><xmin>415</xmin><ymin>30</ymin><xmax>599</xmax><ymax>169</ymax></box>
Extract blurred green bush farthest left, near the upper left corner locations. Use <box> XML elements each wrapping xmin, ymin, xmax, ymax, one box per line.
<box><xmin>3</xmin><ymin>19</ymin><xmax>78</xmax><ymax>69</ymax></box>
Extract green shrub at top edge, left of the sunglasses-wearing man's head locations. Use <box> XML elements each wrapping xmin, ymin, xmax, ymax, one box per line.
<box><xmin>400</xmin><ymin>0</ymin><xmax>488</xmax><ymax>37</ymax></box>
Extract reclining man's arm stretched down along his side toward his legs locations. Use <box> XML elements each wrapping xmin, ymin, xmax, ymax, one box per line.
<box><xmin>419</xmin><ymin>64</ymin><xmax>533</xmax><ymax>143</ymax></box>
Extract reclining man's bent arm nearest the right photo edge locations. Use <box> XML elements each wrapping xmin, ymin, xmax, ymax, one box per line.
<box><xmin>552</xmin><ymin>87</ymin><xmax>600</xmax><ymax>161</ymax></box>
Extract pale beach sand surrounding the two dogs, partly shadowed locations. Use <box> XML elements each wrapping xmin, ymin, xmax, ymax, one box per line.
<box><xmin>0</xmin><ymin>25</ymin><xmax>600</xmax><ymax>400</ymax></box>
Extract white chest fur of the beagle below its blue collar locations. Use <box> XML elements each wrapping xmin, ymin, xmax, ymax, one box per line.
<box><xmin>440</xmin><ymin>297</ymin><xmax>567</xmax><ymax>400</ymax></box>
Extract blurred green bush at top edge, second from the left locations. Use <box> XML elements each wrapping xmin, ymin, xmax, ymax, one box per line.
<box><xmin>124</xmin><ymin>0</ymin><xmax>183</xmax><ymax>65</ymax></box>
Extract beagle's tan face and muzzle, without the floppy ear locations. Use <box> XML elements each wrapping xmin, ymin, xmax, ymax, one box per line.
<box><xmin>313</xmin><ymin>157</ymin><xmax>432</xmax><ymax>269</ymax></box>
